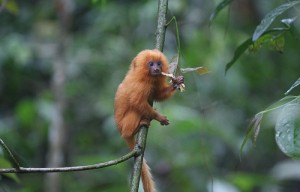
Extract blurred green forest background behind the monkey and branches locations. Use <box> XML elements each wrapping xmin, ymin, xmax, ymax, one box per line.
<box><xmin>0</xmin><ymin>0</ymin><xmax>300</xmax><ymax>192</ymax></box>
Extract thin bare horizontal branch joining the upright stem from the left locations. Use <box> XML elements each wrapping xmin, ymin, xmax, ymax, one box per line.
<box><xmin>0</xmin><ymin>150</ymin><xmax>139</xmax><ymax>173</ymax></box>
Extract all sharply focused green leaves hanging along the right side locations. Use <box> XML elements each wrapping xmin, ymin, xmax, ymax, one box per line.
<box><xmin>210</xmin><ymin>0</ymin><xmax>300</xmax><ymax>158</ymax></box>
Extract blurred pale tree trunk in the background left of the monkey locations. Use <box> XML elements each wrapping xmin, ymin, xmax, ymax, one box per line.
<box><xmin>44</xmin><ymin>0</ymin><xmax>73</xmax><ymax>192</ymax></box>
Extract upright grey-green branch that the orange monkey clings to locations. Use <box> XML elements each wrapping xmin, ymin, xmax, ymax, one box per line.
<box><xmin>130</xmin><ymin>0</ymin><xmax>168</xmax><ymax>192</ymax></box>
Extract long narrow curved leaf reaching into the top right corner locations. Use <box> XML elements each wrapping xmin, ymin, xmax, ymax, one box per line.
<box><xmin>252</xmin><ymin>1</ymin><xmax>300</xmax><ymax>42</ymax></box>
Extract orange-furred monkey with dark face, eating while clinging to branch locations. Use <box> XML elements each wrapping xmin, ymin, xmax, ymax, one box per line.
<box><xmin>114</xmin><ymin>49</ymin><xmax>184</xmax><ymax>192</ymax></box>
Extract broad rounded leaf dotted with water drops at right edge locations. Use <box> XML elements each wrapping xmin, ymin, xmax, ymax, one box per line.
<box><xmin>275</xmin><ymin>99</ymin><xmax>300</xmax><ymax>158</ymax></box>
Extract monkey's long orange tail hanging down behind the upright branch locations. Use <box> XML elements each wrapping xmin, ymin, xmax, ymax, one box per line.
<box><xmin>125</xmin><ymin>137</ymin><xmax>156</xmax><ymax>192</ymax></box>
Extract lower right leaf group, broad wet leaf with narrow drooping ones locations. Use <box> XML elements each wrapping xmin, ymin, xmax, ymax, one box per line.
<box><xmin>240</xmin><ymin>96</ymin><xmax>300</xmax><ymax>158</ymax></box>
